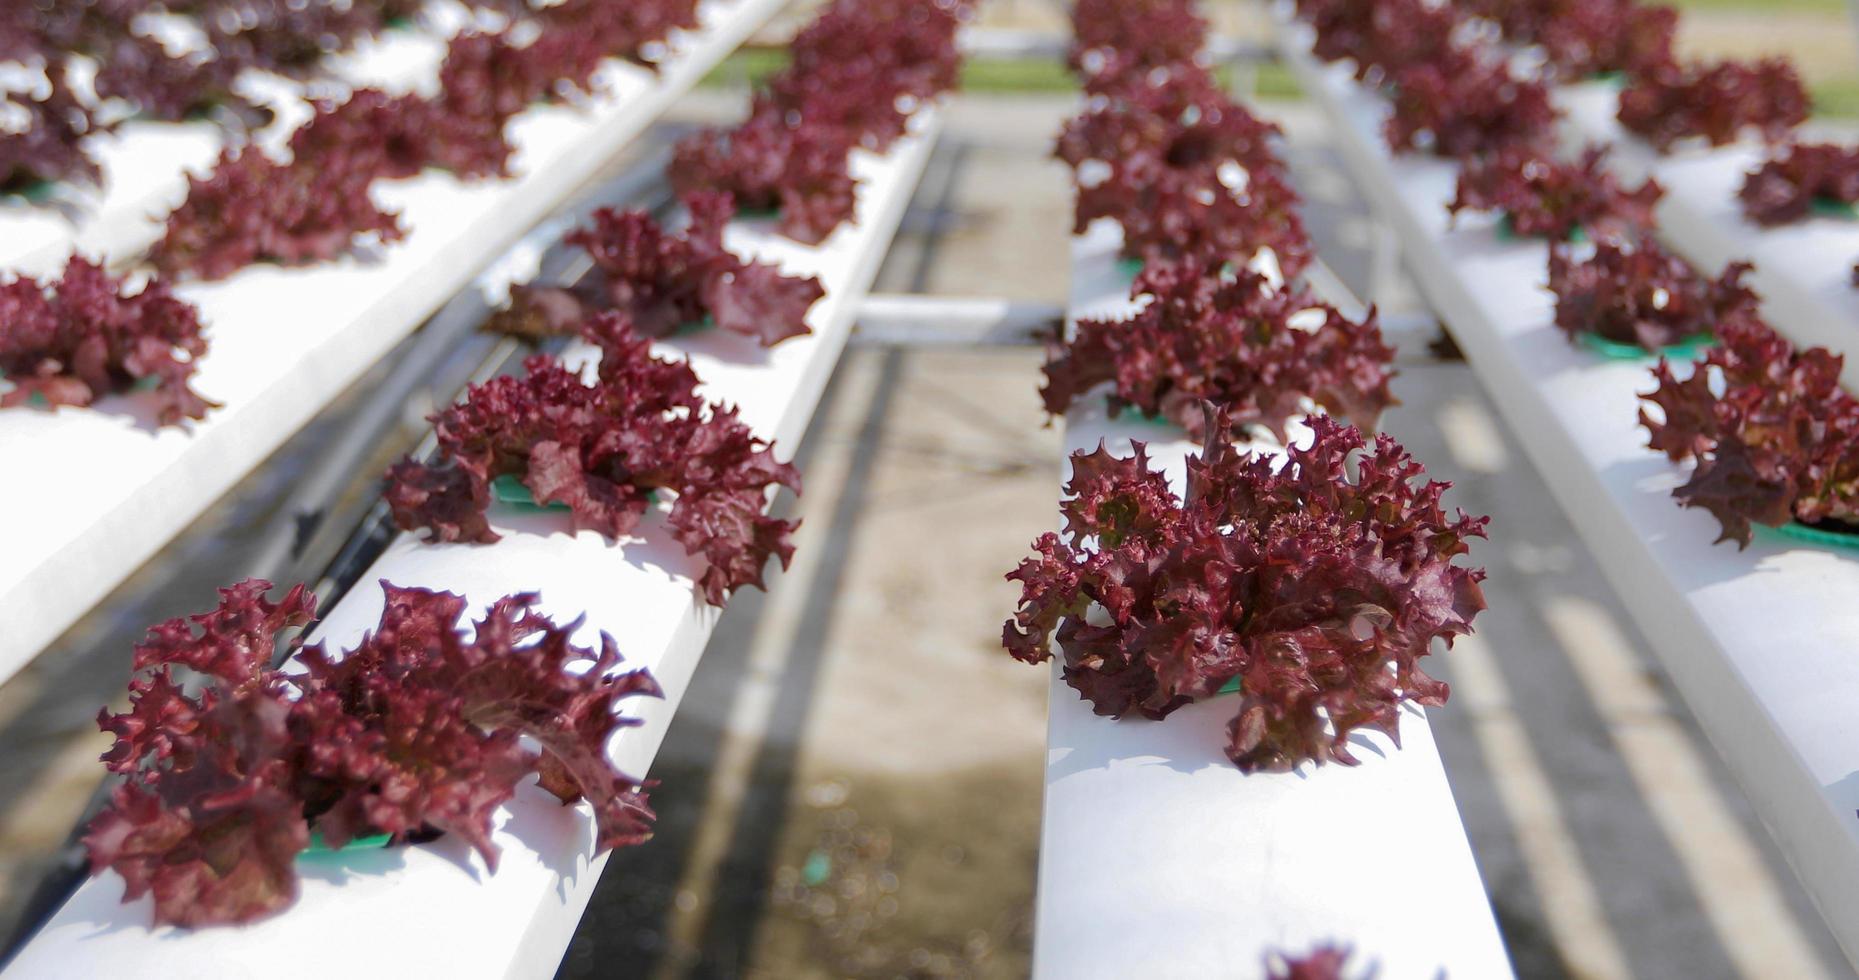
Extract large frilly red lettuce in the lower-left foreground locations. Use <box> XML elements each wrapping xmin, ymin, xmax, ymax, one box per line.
<box><xmin>84</xmin><ymin>580</ymin><xmax>658</xmax><ymax>926</ymax></box>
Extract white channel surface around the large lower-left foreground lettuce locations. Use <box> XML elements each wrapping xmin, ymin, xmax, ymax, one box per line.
<box><xmin>6</xmin><ymin>112</ymin><xmax>937</xmax><ymax>980</ymax></box>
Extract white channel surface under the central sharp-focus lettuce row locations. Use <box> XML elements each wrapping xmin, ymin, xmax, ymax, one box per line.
<box><xmin>1034</xmin><ymin>221</ymin><xmax>1511</xmax><ymax>980</ymax></box>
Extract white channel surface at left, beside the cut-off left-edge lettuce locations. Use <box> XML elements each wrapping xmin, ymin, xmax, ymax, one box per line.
<box><xmin>0</xmin><ymin>0</ymin><xmax>786</xmax><ymax>681</ymax></box>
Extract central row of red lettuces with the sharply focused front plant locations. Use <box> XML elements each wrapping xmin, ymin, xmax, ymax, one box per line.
<box><xmin>1004</xmin><ymin>0</ymin><xmax>1485</xmax><ymax>978</ymax></box>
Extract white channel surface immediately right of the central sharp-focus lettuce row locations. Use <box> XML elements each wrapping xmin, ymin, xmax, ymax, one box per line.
<box><xmin>1281</xmin><ymin>28</ymin><xmax>1859</xmax><ymax>958</ymax></box>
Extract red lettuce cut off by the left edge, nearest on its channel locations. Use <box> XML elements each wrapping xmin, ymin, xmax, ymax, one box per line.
<box><xmin>0</xmin><ymin>257</ymin><xmax>218</xmax><ymax>426</ymax></box>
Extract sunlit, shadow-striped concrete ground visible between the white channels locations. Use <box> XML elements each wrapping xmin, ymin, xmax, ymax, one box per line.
<box><xmin>0</xmin><ymin>44</ymin><xmax>1852</xmax><ymax>978</ymax></box>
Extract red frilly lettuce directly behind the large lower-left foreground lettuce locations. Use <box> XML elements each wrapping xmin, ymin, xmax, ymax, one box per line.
<box><xmin>387</xmin><ymin>312</ymin><xmax>799</xmax><ymax>606</ymax></box>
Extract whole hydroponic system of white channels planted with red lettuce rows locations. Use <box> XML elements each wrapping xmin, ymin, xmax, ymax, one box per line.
<box><xmin>0</xmin><ymin>0</ymin><xmax>1859</xmax><ymax>980</ymax></box>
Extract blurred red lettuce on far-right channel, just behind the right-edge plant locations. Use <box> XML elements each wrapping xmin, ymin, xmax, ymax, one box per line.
<box><xmin>1619</xmin><ymin>58</ymin><xmax>1811</xmax><ymax>152</ymax></box>
